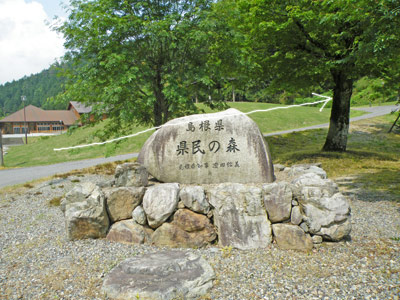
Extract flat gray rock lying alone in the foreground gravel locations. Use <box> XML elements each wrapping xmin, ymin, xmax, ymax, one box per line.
<box><xmin>102</xmin><ymin>251</ymin><xmax>215</xmax><ymax>300</ymax></box>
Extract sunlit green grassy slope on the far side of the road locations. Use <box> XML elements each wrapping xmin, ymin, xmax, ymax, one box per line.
<box><xmin>1</xmin><ymin>102</ymin><xmax>368</xmax><ymax>167</ymax></box>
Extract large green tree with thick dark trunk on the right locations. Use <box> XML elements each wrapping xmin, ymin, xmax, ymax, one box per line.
<box><xmin>216</xmin><ymin>0</ymin><xmax>400</xmax><ymax>151</ymax></box>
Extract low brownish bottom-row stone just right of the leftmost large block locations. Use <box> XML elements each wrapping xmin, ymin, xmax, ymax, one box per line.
<box><xmin>107</xmin><ymin>220</ymin><xmax>153</xmax><ymax>244</ymax></box>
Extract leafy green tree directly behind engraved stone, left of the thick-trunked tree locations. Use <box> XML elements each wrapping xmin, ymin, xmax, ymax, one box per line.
<box><xmin>58</xmin><ymin>0</ymin><xmax>214</xmax><ymax>126</ymax></box>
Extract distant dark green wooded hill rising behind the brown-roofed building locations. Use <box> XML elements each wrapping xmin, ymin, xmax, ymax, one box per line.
<box><xmin>0</xmin><ymin>64</ymin><xmax>67</xmax><ymax>118</ymax></box>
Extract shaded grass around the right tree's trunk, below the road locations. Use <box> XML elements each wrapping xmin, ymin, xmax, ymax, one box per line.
<box><xmin>266</xmin><ymin>115</ymin><xmax>400</xmax><ymax>203</ymax></box>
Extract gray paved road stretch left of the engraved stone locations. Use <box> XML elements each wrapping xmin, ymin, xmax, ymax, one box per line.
<box><xmin>0</xmin><ymin>153</ymin><xmax>138</xmax><ymax>188</ymax></box>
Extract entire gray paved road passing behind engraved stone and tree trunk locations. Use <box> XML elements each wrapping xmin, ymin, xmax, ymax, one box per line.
<box><xmin>0</xmin><ymin>105</ymin><xmax>398</xmax><ymax>188</ymax></box>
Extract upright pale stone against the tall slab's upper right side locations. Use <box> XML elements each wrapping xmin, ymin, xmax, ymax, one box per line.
<box><xmin>263</xmin><ymin>182</ymin><xmax>293</xmax><ymax>223</ymax></box>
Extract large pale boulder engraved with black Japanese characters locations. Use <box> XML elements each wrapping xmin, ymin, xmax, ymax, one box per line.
<box><xmin>138</xmin><ymin>109</ymin><xmax>274</xmax><ymax>184</ymax></box>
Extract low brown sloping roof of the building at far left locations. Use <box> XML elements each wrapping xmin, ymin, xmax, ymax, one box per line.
<box><xmin>0</xmin><ymin>105</ymin><xmax>77</xmax><ymax>125</ymax></box>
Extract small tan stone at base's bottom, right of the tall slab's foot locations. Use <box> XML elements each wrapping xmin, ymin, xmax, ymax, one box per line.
<box><xmin>272</xmin><ymin>224</ymin><xmax>313</xmax><ymax>251</ymax></box>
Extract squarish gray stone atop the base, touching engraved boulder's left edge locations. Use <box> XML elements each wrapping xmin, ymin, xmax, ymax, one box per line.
<box><xmin>115</xmin><ymin>163</ymin><xmax>149</xmax><ymax>187</ymax></box>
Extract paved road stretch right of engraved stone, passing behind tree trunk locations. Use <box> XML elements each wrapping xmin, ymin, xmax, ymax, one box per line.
<box><xmin>264</xmin><ymin>105</ymin><xmax>399</xmax><ymax>136</ymax></box>
